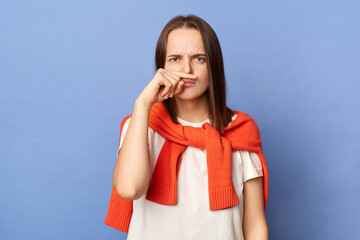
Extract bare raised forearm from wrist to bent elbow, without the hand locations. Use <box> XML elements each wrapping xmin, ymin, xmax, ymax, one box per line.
<box><xmin>113</xmin><ymin>99</ymin><xmax>152</xmax><ymax>200</ymax></box>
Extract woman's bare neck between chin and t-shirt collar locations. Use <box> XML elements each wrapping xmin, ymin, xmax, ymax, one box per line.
<box><xmin>174</xmin><ymin>94</ymin><xmax>210</xmax><ymax>123</ymax></box>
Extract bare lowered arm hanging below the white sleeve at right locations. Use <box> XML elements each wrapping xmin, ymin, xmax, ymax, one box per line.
<box><xmin>243</xmin><ymin>177</ymin><xmax>269</xmax><ymax>240</ymax></box>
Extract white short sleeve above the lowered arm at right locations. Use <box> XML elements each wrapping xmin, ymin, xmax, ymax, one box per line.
<box><xmin>240</xmin><ymin>151</ymin><xmax>263</xmax><ymax>182</ymax></box>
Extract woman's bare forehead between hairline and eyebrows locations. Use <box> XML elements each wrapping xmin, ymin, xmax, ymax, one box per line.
<box><xmin>166</xmin><ymin>28</ymin><xmax>205</xmax><ymax>53</ymax></box>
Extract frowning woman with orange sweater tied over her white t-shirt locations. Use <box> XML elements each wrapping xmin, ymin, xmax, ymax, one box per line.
<box><xmin>105</xmin><ymin>15</ymin><xmax>268</xmax><ymax>240</ymax></box>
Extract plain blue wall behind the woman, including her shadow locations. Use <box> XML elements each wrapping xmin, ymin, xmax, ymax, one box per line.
<box><xmin>0</xmin><ymin>0</ymin><xmax>360</xmax><ymax>240</ymax></box>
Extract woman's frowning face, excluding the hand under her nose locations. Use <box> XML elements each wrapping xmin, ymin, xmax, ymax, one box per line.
<box><xmin>164</xmin><ymin>28</ymin><xmax>209</xmax><ymax>100</ymax></box>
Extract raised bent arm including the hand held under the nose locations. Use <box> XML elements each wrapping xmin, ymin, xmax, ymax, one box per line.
<box><xmin>113</xmin><ymin>68</ymin><xmax>197</xmax><ymax>200</ymax></box>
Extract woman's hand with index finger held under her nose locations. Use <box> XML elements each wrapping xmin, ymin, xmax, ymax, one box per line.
<box><xmin>138</xmin><ymin>68</ymin><xmax>197</xmax><ymax>104</ymax></box>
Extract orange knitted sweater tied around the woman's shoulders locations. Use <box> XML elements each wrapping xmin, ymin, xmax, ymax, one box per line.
<box><xmin>105</xmin><ymin>102</ymin><xmax>268</xmax><ymax>232</ymax></box>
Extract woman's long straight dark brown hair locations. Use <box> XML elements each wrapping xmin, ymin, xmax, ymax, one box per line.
<box><xmin>155</xmin><ymin>15</ymin><xmax>234</xmax><ymax>134</ymax></box>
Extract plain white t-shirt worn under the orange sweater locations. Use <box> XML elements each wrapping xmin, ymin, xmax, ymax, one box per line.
<box><xmin>116</xmin><ymin>114</ymin><xmax>263</xmax><ymax>240</ymax></box>
